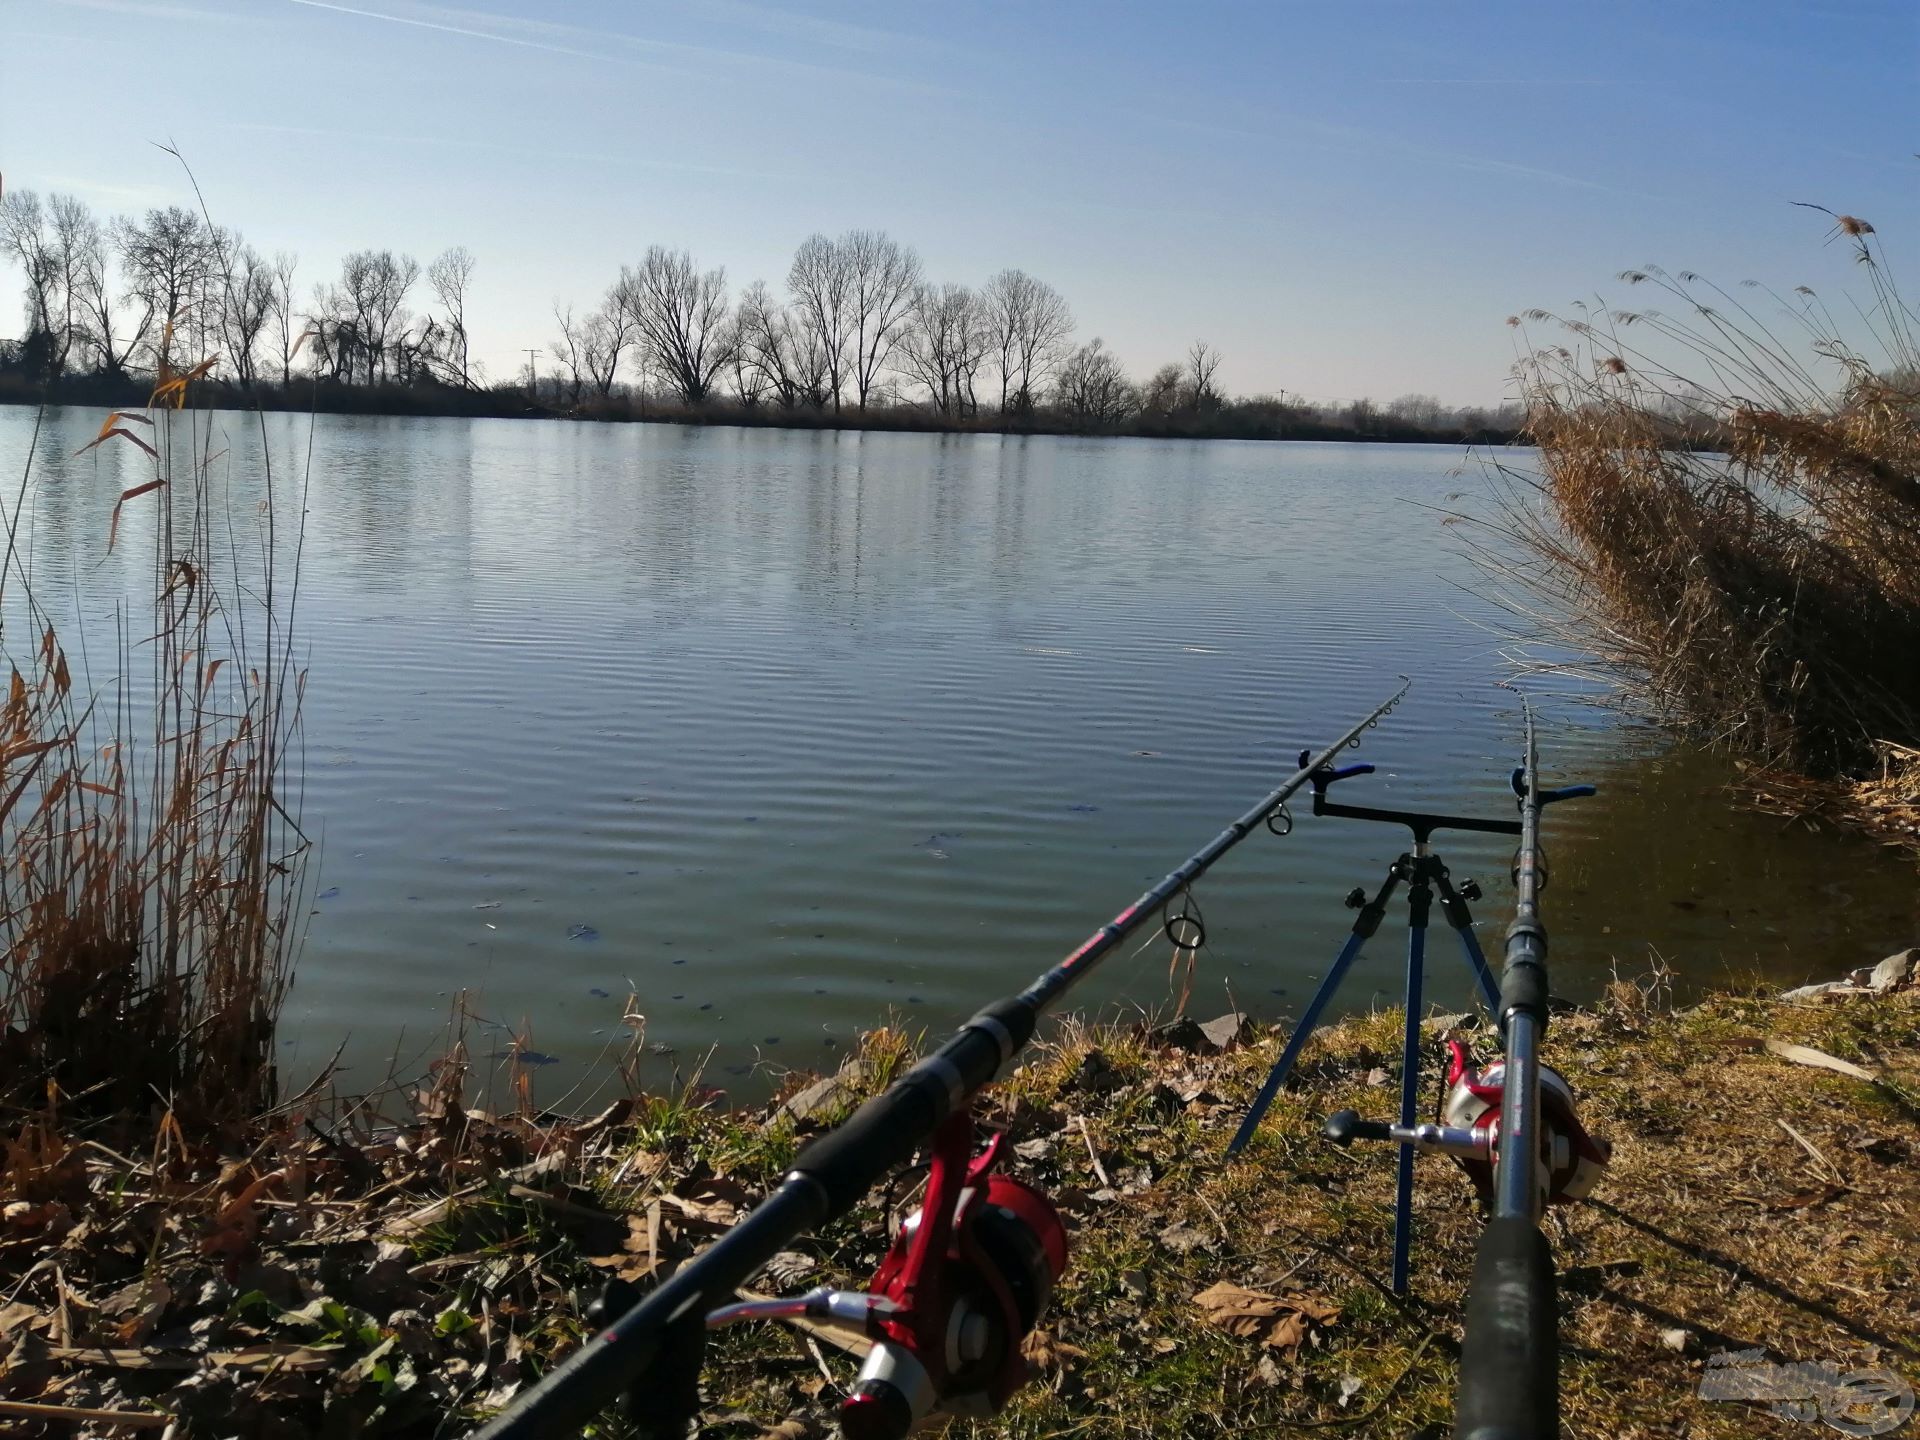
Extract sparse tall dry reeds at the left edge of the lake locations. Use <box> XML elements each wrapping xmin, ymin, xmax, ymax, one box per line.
<box><xmin>0</xmin><ymin>336</ymin><xmax>309</xmax><ymax>1117</ymax></box>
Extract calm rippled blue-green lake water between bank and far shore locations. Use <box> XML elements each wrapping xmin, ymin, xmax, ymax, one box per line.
<box><xmin>0</xmin><ymin>407</ymin><xmax>1920</xmax><ymax>1091</ymax></box>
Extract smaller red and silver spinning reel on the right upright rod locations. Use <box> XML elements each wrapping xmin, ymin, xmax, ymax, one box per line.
<box><xmin>1325</xmin><ymin>1041</ymin><xmax>1613</xmax><ymax>1206</ymax></box>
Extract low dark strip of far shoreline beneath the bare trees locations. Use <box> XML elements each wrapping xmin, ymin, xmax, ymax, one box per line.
<box><xmin>0</xmin><ymin>376</ymin><xmax>1524</xmax><ymax>445</ymax></box>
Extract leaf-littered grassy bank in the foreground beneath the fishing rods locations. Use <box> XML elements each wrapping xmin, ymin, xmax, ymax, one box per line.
<box><xmin>0</xmin><ymin>971</ymin><xmax>1920</xmax><ymax>1440</ymax></box>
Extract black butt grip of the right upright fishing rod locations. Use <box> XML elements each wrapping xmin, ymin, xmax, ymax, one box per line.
<box><xmin>1453</xmin><ymin>1215</ymin><xmax>1559</xmax><ymax>1440</ymax></box>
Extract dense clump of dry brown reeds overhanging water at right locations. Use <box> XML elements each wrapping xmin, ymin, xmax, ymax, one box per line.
<box><xmin>1482</xmin><ymin>215</ymin><xmax>1920</xmax><ymax>806</ymax></box>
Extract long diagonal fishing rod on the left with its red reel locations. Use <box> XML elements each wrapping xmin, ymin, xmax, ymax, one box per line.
<box><xmin>474</xmin><ymin>676</ymin><xmax>1413</xmax><ymax>1440</ymax></box>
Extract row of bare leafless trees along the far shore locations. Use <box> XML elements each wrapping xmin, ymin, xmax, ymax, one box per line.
<box><xmin>0</xmin><ymin>190</ymin><xmax>1513</xmax><ymax>438</ymax></box>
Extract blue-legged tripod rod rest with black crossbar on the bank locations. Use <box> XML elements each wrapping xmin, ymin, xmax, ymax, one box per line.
<box><xmin>1227</xmin><ymin>755</ymin><xmax>1521</xmax><ymax>1294</ymax></box>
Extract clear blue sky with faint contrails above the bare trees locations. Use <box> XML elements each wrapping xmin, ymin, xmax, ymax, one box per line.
<box><xmin>0</xmin><ymin>0</ymin><xmax>1920</xmax><ymax>403</ymax></box>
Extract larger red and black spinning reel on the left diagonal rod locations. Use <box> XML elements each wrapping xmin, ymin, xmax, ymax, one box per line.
<box><xmin>707</xmin><ymin>1110</ymin><xmax>1068</xmax><ymax>1440</ymax></box>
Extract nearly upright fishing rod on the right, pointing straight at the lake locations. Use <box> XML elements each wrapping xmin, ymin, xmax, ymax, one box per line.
<box><xmin>1453</xmin><ymin>697</ymin><xmax>1605</xmax><ymax>1440</ymax></box>
